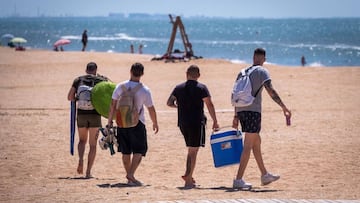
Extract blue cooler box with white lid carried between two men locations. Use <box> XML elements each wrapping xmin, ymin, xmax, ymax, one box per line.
<box><xmin>210</xmin><ymin>130</ymin><xmax>243</xmax><ymax>167</ymax></box>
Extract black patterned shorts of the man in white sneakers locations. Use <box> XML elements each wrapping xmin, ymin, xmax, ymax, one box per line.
<box><xmin>237</xmin><ymin>111</ymin><xmax>261</xmax><ymax>133</ymax></box>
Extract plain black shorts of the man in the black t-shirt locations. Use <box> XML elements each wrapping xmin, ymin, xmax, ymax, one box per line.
<box><xmin>179</xmin><ymin>125</ymin><xmax>205</xmax><ymax>147</ymax></box>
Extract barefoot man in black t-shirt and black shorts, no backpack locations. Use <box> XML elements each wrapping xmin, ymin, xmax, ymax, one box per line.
<box><xmin>167</xmin><ymin>65</ymin><xmax>219</xmax><ymax>189</ymax></box>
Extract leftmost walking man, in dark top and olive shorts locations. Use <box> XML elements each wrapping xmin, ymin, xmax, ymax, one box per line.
<box><xmin>68</xmin><ymin>62</ymin><xmax>108</xmax><ymax>178</ymax></box>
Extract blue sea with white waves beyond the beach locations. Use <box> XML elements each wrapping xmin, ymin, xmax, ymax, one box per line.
<box><xmin>0</xmin><ymin>16</ymin><xmax>360</xmax><ymax>66</ymax></box>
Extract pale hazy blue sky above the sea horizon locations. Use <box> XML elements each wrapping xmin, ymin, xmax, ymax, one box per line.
<box><xmin>0</xmin><ymin>0</ymin><xmax>360</xmax><ymax>18</ymax></box>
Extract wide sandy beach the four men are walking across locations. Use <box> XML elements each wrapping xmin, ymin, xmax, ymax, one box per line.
<box><xmin>0</xmin><ymin>47</ymin><xmax>360</xmax><ymax>202</ymax></box>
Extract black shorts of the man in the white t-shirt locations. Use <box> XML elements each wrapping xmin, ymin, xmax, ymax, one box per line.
<box><xmin>116</xmin><ymin>121</ymin><xmax>148</xmax><ymax>156</ymax></box>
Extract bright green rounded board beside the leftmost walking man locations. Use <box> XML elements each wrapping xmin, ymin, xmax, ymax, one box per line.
<box><xmin>91</xmin><ymin>81</ymin><xmax>116</xmax><ymax>119</ymax></box>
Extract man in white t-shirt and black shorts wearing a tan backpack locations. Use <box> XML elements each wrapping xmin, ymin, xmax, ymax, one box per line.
<box><xmin>108</xmin><ymin>63</ymin><xmax>159</xmax><ymax>186</ymax></box>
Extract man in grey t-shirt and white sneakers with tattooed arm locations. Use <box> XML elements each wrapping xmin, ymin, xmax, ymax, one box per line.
<box><xmin>232</xmin><ymin>48</ymin><xmax>291</xmax><ymax>189</ymax></box>
